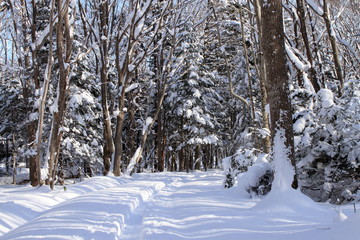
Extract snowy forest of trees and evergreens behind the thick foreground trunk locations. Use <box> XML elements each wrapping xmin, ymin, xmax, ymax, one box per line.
<box><xmin>0</xmin><ymin>0</ymin><xmax>360</xmax><ymax>203</ymax></box>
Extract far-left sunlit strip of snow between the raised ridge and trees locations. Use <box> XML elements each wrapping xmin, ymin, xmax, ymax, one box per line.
<box><xmin>0</xmin><ymin>177</ymin><xmax>129</xmax><ymax>236</ymax></box>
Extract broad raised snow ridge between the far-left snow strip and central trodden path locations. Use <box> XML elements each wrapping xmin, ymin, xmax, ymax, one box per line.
<box><xmin>1</xmin><ymin>178</ymin><xmax>165</xmax><ymax>240</ymax></box>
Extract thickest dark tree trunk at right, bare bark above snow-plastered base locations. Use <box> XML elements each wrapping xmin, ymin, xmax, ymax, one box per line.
<box><xmin>261</xmin><ymin>0</ymin><xmax>298</xmax><ymax>189</ymax></box>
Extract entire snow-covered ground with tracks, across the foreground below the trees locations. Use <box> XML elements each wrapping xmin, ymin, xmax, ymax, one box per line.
<box><xmin>0</xmin><ymin>171</ymin><xmax>360</xmax><ymax>240</ymax></box>
